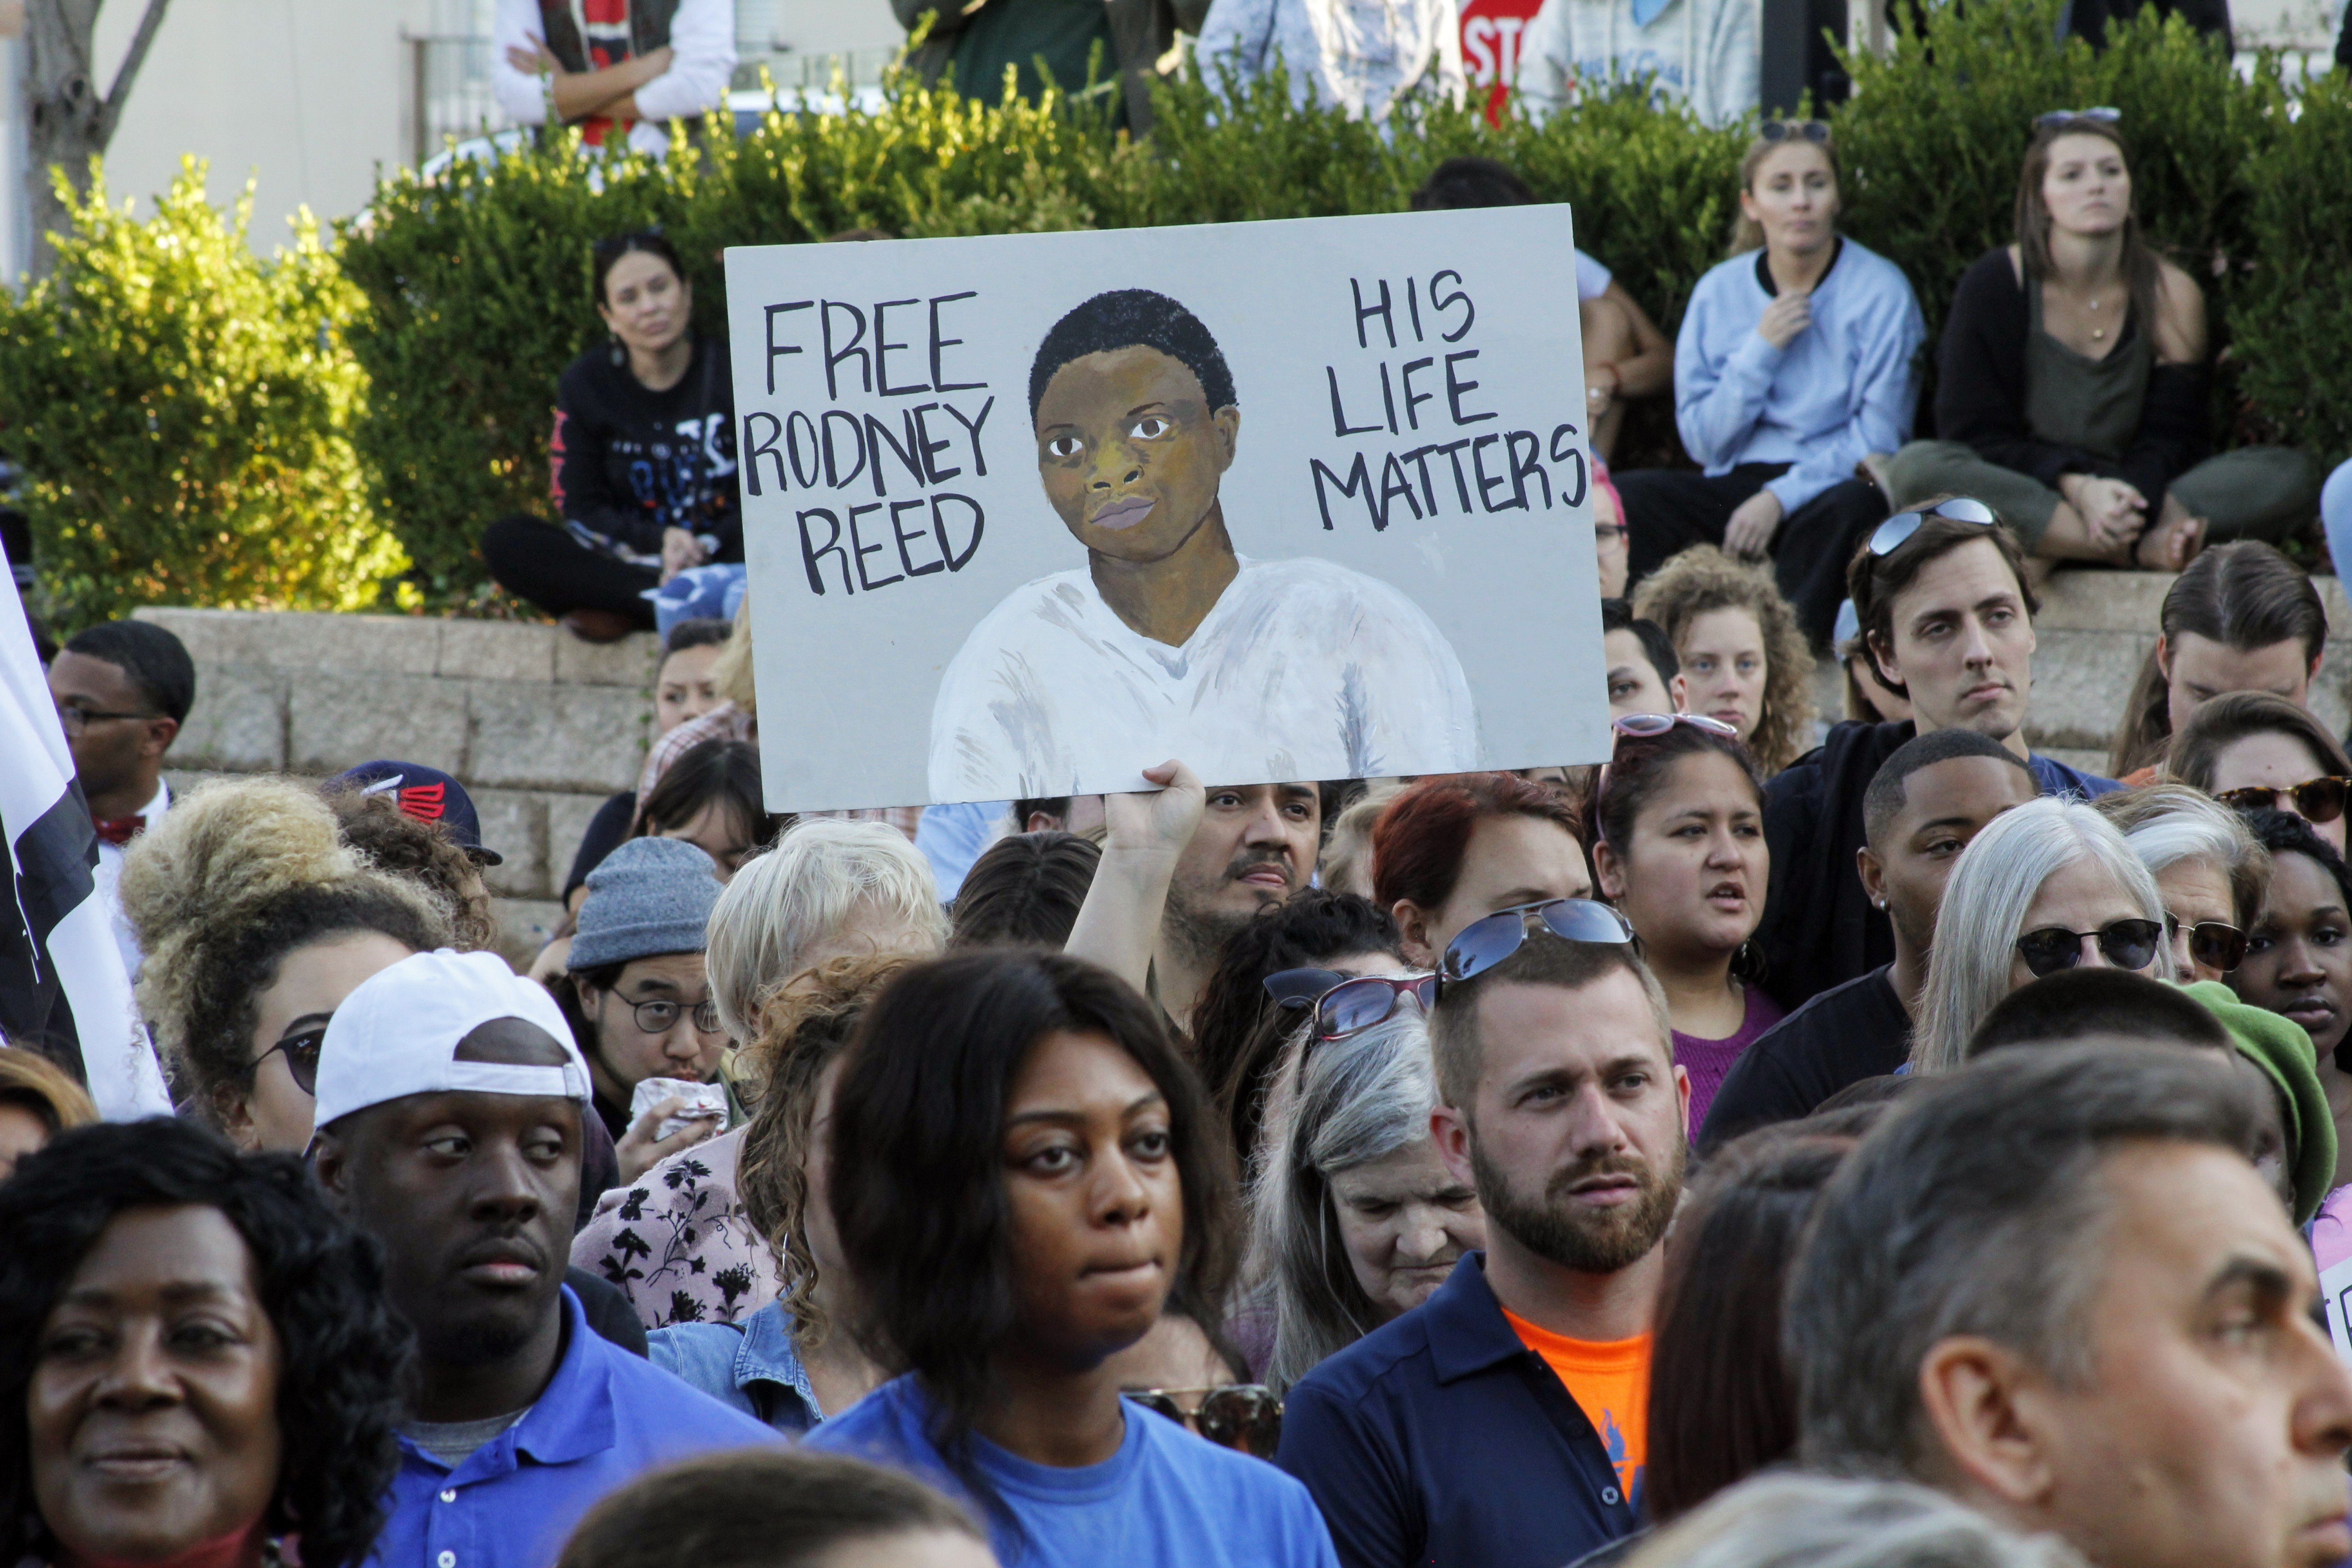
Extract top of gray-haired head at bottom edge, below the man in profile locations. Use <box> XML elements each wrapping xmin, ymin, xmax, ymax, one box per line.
<box><xmin>1625</xmin><ymin>1472</ymin><xmax>2086</xmax><ymax>1568</ymax></box>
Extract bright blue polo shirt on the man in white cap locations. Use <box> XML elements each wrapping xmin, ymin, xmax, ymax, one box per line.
<box><xmin>369</xmin><ymin>1286</ymin><xmax>776</xmax><ymax>1568</ymax></box>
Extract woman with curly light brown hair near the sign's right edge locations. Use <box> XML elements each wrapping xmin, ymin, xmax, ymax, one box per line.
<box><xmin>1632</xmin><ymin>545</ymin><xmax>1813</xmax><ymax>778</ymax></box>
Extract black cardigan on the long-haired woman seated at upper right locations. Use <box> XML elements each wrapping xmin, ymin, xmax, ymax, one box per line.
<box><xmin>1936</xmin><ymin>245</ymin><xmax>2213</xmax><ymax>517</ymax></box>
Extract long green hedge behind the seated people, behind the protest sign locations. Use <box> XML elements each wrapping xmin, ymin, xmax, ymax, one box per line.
<box><xmin>14</xmin><ymin>0</ymin><xmax>2352</xmax><ymax>604</ymax></box>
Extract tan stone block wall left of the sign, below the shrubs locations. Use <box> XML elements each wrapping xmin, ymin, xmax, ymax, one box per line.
<box><xmin>139</xmin><ymin>609</ymin><xmax>659</xmax><ymax>959</ymax></box>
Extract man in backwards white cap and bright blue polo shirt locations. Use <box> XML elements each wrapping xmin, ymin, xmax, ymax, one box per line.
<box><xmin>313</xmin><ymin>952</ymin><xmax>776</xmax><ymax>1568</ymax></box>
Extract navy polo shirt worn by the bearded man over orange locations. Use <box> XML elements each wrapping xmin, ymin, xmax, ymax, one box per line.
<box><xmin>1275</xmin><ymin>1253</ymin><xmax>1639</xmax><ymax>1568</ymax></box>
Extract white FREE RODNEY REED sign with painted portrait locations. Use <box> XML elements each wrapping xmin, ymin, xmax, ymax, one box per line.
<box><xmin>727</xmin><ymin>207</ymin><xmax>1609</xmax><ymax>811</ymax></box>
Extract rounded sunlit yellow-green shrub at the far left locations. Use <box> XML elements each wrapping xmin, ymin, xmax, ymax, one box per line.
<box><xmin>0</xmin><ymin>160</ymin><xmax>407</xmax><ymax>627</ymax></box>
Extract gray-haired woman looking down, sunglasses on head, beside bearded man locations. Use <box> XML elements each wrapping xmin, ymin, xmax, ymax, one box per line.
<box><xmin>1251</xmin><ymin>1006</ymin><xmax>1486</xmax><ymax>1394</ymax></box>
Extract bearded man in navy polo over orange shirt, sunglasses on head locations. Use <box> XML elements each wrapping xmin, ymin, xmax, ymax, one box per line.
<box><xmin>1277</xmin><ymin>921</ymin><xmax>1691</xmax><ymax>1568</ymax></box>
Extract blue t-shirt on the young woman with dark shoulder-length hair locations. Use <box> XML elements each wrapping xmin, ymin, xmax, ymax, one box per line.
<box><xmin>807</xmin><ymin>1375</ymin><xmax>1338</xmax><ymax>1568</ymax></box>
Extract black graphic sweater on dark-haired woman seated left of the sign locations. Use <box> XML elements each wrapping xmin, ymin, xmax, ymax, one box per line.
<box><xmin>548</xmin><ymin>334</ymin><xmax>743</xmax><ymax>562</ymax></box>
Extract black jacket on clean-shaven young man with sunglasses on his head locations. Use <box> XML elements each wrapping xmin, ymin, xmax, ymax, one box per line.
<box><xmin>1754</xmin><ymin>720</ymin><xmax>1917</xmax><ymax>1013</ymax></box>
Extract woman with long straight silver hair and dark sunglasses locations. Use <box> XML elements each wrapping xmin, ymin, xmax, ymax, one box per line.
<box><xmin>1910</xmin><ymin>797</ymin><xmax>2173</xmax><ymax>1072</ymax></box>
